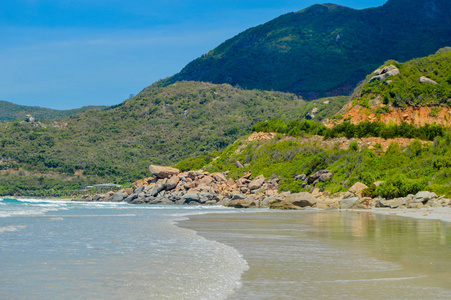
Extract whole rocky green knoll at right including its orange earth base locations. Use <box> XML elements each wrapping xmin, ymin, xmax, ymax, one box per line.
<box><xmin>340</xmin><ymin>47</ymin><xmax>451</xmax><ymax>126</ymax></box>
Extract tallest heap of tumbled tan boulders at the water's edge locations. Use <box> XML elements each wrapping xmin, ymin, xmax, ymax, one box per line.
<box><xmin>77</xmin><ymin>165</ymin><xmax>279</xmax><ymax>207</ymax></box>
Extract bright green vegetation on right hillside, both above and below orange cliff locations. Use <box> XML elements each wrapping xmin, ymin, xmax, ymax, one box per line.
<box><xmin>174</xmin><ymin>48</ymin><xmax>451</xmax><ymax>198</ymax></box>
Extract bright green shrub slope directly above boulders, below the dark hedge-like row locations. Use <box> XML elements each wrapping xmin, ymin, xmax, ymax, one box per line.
<box><xmin>178</xmin><ymin>130</ymin><xmax>451</xmax><ymax>198</ymax></box>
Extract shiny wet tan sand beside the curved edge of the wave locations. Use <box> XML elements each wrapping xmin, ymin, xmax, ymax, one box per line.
<box><xmin>179</xmin><ymin>211</ymin><xmax>451</xmax><ymax>299</ymax></box>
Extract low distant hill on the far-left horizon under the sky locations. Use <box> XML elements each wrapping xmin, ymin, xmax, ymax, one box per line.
<box><xmin>0</xmin><ymin>101</ymin><xmax>107</xmax><ymax>121</ymax></box>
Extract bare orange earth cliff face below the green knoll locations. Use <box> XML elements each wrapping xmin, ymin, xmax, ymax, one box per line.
<box><xmin>338</xmin><ymin>105</ymin><xmax>451</xmax><ymax>126</ymax></box>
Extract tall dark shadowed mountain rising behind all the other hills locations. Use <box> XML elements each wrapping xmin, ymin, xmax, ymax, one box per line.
<box><xmin>156</xmin><ymin>0</ymin><xmax>451</xmax><ymax>99</ymax></box>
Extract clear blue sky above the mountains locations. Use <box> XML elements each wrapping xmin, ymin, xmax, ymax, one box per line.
<box><xmin>0</xmin><ymin>0</ymin><xmax>386</xmax><ymax>109</ymax></box>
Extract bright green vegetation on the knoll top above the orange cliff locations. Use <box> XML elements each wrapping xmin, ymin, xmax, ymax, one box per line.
<box><xmin>353</xmin><ymin>47</ymin><xmax>451</xmax><ymax>109</ymax></box>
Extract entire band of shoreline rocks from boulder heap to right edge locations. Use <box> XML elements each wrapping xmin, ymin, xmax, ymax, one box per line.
<box><xmin>72</xmin><ymin>167</ymin><xmax>451</xmax><ymax>210</ymax></box>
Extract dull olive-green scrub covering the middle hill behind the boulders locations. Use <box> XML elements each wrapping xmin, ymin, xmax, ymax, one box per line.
<box><xmin>0</xmin><ymin>82</ymin><xmax>343</xmax><ymax>194</ymax></box>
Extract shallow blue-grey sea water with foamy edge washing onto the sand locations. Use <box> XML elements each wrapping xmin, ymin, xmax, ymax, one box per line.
<box><xmin>0</xmin><ymin>199</ymin><xmax>248</xmax><ymax>299</ymax></box>
